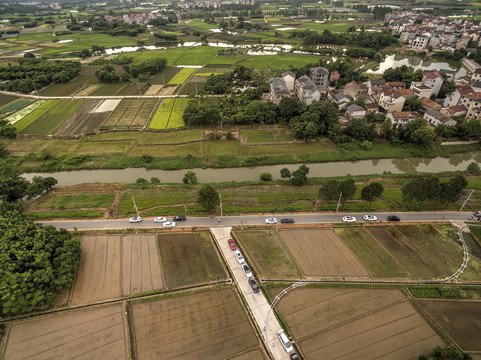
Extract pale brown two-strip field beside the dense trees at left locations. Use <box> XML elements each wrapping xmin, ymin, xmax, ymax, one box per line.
<box><xmin>71</xmin><ymin>234</ymin><xmax>164</xmax><ymax>304</ymax></box>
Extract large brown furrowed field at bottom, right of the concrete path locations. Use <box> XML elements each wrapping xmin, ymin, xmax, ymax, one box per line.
<box><xmin>278</xmin><ymin>288</ymin><xmax>444</xmax><ymax>360</ymax></box>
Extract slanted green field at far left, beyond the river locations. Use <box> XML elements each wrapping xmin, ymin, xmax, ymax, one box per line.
<box><xmin>20</xmin><ymin>100</ymin><xmax>87</xmax><ymax>135</ymax></box>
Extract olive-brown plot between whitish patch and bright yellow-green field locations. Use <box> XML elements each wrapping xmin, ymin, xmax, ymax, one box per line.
<box><xmin>103</xmin><ymin>99</ymin><xmax>158</xmax><ymax>128</ymax></box>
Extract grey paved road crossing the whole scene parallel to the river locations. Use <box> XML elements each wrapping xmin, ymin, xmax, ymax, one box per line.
<box><xmin>41</xmin><ymin>211</ymin><xmax>472</xmax><ymax>230</ymax></box>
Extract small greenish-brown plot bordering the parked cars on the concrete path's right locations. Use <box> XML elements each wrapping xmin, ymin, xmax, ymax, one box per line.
<box><xmin>235</xmin><ymin>230</ymin><xmax>301</xmax><ymax>279</ymax></box>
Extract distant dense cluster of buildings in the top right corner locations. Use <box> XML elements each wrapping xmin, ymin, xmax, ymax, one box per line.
<box><xmin>385</xmin><ymin>11</ymin><xmax>481</xmax><ymax>50</ymax></box>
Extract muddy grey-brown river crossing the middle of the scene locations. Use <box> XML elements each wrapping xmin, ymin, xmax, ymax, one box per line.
<box><xmin>23</xmin><ymin>151</ymin><xmax>481</xmax><ymax>185</ymax></box>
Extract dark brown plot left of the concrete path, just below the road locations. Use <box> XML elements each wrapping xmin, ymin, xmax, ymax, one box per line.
<box><xmin>158</xmin><ymin>232</ymin><xmax>227</xmax><ymax>289</ymax></box>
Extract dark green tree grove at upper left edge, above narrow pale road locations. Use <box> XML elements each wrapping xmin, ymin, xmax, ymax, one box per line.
<box><xmin>0</xmin><ymin>58</ymin><xmax>81</xmax><ymax>93</ymax></box>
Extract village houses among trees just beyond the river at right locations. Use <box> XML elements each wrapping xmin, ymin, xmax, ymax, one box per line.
<box><xmin>265</xmin><ymin>66</ymin><xmax>481</xmax><ymax>127</ymax></box>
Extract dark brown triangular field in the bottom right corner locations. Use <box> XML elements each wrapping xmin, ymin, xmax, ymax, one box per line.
<box><xmin>418</xmin><ymin>300</ymin><xmax>481</xmax><ymax>351</ymax></box>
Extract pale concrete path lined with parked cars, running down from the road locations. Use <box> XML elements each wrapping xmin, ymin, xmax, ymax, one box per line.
<box><xmin>210</xmin><ymin>227</ymin><xmax>289</xmax><ymax>360</ymax></box>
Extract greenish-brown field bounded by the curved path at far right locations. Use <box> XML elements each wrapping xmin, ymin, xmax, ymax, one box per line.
<box><xmin>336</xmin><ymin>225</ymin><xmax>479</xmax><ymax>279</ymax></box>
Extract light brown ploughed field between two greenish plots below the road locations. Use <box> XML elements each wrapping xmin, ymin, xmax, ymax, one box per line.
<box><xmin>279</xmin><ymin>229</ymin><xmax>370</xmax><ymax>277</ymax></box>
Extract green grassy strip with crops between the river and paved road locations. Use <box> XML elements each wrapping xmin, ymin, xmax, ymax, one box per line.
<box><xmin>28</xmin><ymin>172</ymin><xmax>481</xmax><ymax>219</ymax></box>
